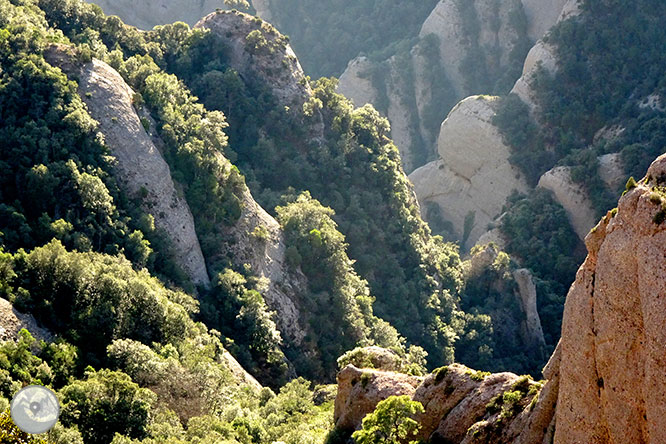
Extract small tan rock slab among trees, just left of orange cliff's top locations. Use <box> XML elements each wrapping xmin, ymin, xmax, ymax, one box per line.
<box><xmin>538</xmin><ymin>167</ymin><xmax>597</xmax><ymax>240</ymax></box>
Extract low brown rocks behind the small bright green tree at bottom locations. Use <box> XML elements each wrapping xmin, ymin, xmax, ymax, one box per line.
<box><xmin>334</xmin><ymin>364</ymin><xmax>557</xmax><ymax>444</ymax></box>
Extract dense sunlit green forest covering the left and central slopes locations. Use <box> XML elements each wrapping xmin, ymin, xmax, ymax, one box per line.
<box><xmin>0</xmin><ymin>0</ymin><xmax>542</xmax><ymax>444</ymax></box>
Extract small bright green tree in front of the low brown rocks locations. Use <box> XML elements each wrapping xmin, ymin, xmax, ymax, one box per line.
<box><xmin>352</xmin><ymin>395</ymin><xmax>424</xmax><ymax>444</ymax></box>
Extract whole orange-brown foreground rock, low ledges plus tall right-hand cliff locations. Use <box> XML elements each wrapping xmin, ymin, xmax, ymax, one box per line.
<box><xmin>335</xmin><ymin>155</ymin><xmax>666</xmax><ymax>444</ymax></box>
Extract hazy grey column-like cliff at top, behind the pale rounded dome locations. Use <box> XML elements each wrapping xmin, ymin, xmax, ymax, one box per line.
<box><xmin>338</xmin><ymin>0</ymin><xmax>571</xmax><ymax>172</ymax></box>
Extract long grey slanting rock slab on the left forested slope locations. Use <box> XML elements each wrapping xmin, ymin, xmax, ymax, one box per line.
<box><xmin>46</xmin><ymin>46</ymin><xmax>210</xmax><ymax>285</ymax></box>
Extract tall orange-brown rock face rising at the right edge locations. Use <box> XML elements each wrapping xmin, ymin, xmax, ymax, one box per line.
<box><xmin>555</xmin><ymin>156</ymin><xmax>666</xmax><ymax>444</ymax></box>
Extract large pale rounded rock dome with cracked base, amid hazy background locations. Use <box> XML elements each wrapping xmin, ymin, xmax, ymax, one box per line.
<box><xmin>409</xmin><ymin>96</ymin><xmax>528</xmax><ymax>245</ymax></box>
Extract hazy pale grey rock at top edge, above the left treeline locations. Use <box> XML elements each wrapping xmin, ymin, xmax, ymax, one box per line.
<box><xmin>85</xmin><ymin>0</ymin><xmax>226</xmax><ymax>29</ymax></box>
